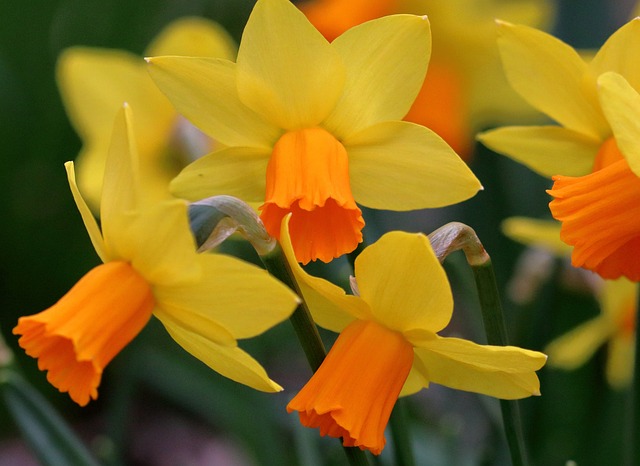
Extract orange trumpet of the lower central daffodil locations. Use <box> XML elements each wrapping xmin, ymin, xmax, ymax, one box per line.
<box><xmin>287</xmin><ymin>320</ymin><xmax>413</xmax><ymax>455</ymax></box>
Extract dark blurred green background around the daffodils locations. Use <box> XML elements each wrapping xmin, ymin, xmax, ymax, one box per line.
<box><xmin>0</xmin><ymin>0</ymin><xmax>633</xmax><ymax>466</ymax></box>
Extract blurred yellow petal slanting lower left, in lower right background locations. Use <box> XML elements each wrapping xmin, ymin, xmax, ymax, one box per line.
<box><xmin>545</xmin><ymin>317</ymin><xmax>614</xmax><ymax>369</ymax></box>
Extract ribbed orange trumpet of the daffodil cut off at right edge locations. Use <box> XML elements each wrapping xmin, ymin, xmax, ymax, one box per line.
<box><xmin>548</xmin><ymin>138</ymin><xmax>640</xmax><ymax>281</ymax></box>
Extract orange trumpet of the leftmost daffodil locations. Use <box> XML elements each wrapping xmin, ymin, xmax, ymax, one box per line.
<box><xmin>13</xmin><ymin>261</ymin><xmax>155</xmax><ymax>406</ymax></box>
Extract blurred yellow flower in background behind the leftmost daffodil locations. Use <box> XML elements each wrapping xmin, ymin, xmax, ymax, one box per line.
<box><xmin>57</xmin><ymin>18</ymin><xmax>236</xmax><ymax>212</ymax></box>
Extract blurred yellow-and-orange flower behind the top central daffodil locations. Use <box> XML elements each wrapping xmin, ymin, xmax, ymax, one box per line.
<box><xmin>298</xmin><ymin>0</ymin><xmax>552</xmax><ymax>159</ymax></box>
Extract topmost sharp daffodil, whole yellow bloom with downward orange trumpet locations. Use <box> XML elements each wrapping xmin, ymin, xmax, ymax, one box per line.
<box><xmin>148</xmin><ymin>0</ymin><xmax>480</xmax><ymax>263</ymax></box>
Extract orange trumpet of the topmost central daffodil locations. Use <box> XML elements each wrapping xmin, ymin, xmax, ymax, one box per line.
<box><xmin>260</xmin><ymin>127</ymin><xmax>364</xmax><ymax>264</ymax></box>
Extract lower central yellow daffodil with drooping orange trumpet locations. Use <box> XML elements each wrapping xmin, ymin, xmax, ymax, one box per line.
<box><xmin>281</xmin><ymin>217</ymin><xmax>546</xmax><ymax>454</ymax></box>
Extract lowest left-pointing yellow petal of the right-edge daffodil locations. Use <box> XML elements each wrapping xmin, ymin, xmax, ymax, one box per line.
<box><xmin>478</xmin><ymin>126</ymin><xmax>602</xmax><ymax>178</ymax></box>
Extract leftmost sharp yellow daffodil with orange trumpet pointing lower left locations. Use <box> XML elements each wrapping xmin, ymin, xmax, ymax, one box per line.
<box><xmin>13</xmin><ymin>104</ymin><xmax>297</xmax><ymax>406</ymax></box>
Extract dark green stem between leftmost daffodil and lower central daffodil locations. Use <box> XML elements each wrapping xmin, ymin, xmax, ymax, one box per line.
<box><xmin>260</xmin><ymin>245</ymin><xmax>369</xmax><ymax>466</ymax></box>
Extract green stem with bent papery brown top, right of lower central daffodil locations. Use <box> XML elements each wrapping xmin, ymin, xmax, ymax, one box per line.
<box><xmin>429</xmin><ymin>222</ymin><xmax>527</xmax><ymax>466</ymax></box>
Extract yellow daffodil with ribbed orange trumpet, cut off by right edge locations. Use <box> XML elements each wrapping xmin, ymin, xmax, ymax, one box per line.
<box><xmin>480</xmin><ymin>19</ymin><xmax>640</xmax><ymax>281</ymax></box>
